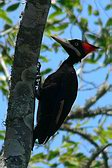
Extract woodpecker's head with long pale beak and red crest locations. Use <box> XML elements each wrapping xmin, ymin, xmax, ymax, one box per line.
<box><xmin>51</xmin><ymin>36</ymin><xmax>99</xmax><ymax>63</ymax></box>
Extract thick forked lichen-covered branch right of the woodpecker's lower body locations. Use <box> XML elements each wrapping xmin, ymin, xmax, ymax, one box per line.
<box><xmin>67</xmin><ymin>83</ymin><xmax>112</xmax><ymax>121</ymax></box>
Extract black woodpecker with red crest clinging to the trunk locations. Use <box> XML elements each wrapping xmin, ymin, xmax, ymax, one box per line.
<box><xmin>32</xmin><ymin>36</ymin><xmax>98</xmax><ymax>146</ymax></box>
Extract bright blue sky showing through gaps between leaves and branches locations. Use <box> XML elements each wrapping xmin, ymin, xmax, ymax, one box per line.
<box><xmin>0</xmin><ymin>0</ymin><xmax>112</xmax><ymax>165</ymax></box>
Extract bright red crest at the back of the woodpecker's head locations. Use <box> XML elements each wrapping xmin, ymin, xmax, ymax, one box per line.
<box><xmin>82</xmin><ymin>42</ymin><xmax>99</xmax><ymax>55</ymax></box>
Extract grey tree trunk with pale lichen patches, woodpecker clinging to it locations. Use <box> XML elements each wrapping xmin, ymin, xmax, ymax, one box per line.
<box><xmin>0</xmin><ymin>0</ymin><xmax>51</xmax><ymax>168</ymax></box>
